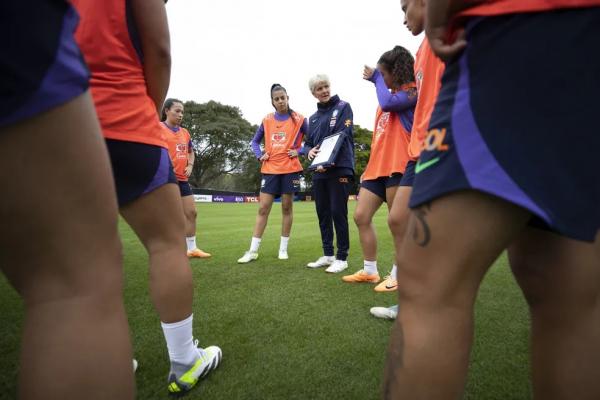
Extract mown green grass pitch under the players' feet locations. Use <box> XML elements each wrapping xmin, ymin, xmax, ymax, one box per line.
<box><xmin>0</xmin><ymin>203</ymin><xmax>531</xmax><ymax>400</ymax></box>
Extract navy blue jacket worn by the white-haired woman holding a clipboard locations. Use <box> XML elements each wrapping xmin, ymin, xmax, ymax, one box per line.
<box><xmin>302</xmin><ymin>95</ymin><xmax>354</xmax><ymax>179</ymax></box>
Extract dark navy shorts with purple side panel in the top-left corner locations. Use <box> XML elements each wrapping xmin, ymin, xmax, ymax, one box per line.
<box><xmin>0</xmin><ymin>0</ymin><xmax>89</xmax><ymax>127</ymax></box>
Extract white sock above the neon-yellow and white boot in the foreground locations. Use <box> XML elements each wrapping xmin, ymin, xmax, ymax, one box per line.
<box><xmin>160</xmin><ymin>314</ymin><xmax>198</xmax><ymax>365</ymax></box>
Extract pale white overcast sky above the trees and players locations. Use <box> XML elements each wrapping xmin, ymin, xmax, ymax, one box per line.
<box><xmin>167</xmin><ymin>0</ymin><xmax>422</xmax><ymax>130</ymax></box>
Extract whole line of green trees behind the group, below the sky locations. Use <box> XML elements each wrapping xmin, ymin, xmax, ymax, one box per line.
<box><xmin>181</xmin><ymin>101</ymin><xmax>372</xmax><ymax>192</ymax></box>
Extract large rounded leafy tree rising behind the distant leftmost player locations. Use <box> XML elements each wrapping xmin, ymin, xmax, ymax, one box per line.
<box><xmin>182</xmin><ymin>101</ymin><xmax>255</xmax><ymax>187</ymax></box>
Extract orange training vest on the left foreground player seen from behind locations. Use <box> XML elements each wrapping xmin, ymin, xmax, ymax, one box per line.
<box><xmin>71</xmin><ymin>0</ymin><xmax>167</xmax><ymax>148</ymax></box>
